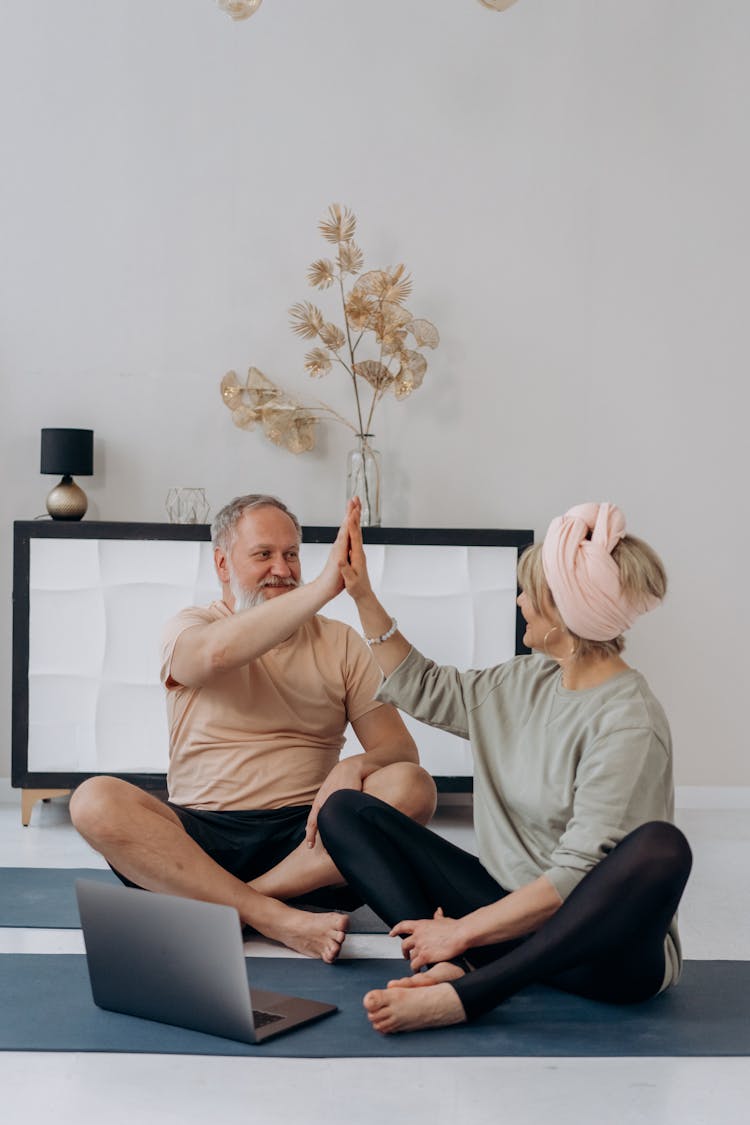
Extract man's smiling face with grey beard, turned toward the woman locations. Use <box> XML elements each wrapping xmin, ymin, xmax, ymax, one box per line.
<box><xmin>216</xmin><ymin>507</ymin><xmax>301</xmax><ymax>613</ymax></box>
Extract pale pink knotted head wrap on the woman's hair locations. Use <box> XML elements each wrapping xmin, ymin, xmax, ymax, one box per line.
<box><xmin>542</xmin><ymin>504</ymin><xmax>659</xmax><ymax>641</ymax></box>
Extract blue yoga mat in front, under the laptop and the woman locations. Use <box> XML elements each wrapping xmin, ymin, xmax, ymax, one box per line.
<box><xmin>0</xmin><ymin>954</ymin><xmax>750</xmax><ymax>1059</ymax></box>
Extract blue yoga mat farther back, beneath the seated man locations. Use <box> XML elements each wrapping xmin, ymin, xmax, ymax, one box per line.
<box><xmin>0</xmin><ymin>867</ymin><xmax>388</xmax><ymax>934</ymax></box>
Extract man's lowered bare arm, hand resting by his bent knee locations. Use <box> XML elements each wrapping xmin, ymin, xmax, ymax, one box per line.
<box><xmin>305</xmin><ymin>703</ymin><xmax>419</xmax><ymax>847</ymax></box>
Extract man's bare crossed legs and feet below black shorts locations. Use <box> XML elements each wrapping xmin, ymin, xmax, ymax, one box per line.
<box><xmin>71</xmin><ymin>763</ymin><xmax>434</xmax><ymax>962</ymax></box>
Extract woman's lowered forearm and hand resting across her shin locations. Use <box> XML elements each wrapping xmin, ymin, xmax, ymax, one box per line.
<box><xmin>390</xmin><ymin>875</ymin><xmax>562</xmax><ymax>970</ymax></box>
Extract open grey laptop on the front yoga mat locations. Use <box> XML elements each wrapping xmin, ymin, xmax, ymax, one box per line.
<box><xmin>75</xmin><ymin>879</ymin><xmax>336</xmax><ymax>1043</ymax></box>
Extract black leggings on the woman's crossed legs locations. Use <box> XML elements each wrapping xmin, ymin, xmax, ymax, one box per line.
<box><xmin>318</xmin><ymin>790</ymin><xmax>693</xmax><ymax>1019</ymax></box>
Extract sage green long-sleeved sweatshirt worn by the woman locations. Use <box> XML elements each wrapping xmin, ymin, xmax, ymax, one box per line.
<box><xmin>378</xmin><ymin>648</ymin><xmax>681</xmax><ymax>988</ymax></box>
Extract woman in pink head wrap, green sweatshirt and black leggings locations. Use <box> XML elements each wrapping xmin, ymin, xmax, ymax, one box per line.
<box><xmin>318</xmin><ymin>502</ymin><xmax>692</xmax><ymax>1033</ymax></box>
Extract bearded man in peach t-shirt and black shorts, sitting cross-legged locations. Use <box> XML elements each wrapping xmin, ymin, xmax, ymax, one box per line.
<box><xmin>71</xmin><ymin>495</ymin><xmax>435</xmax><ymax>962</ymax></box>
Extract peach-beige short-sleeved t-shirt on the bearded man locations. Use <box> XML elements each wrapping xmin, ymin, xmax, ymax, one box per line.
<box><xmin>161</xmin><ymin>601</ymin><xmax>382</xmax><ymax>810</ymax></box>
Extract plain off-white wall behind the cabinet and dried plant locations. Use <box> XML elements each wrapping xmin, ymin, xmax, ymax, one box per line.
<box><xmin>0</xmin><ymin>0</ymin><xmax>750</xmax><ymax>785</ymax></box>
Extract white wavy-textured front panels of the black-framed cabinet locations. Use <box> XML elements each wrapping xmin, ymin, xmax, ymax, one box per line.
<box><xmin>16</xmin><ymin>525</ymin><xmax>530</xmax><ymax>776</ymax></box>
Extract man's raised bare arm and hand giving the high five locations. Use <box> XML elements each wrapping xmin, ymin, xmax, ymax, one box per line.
<box><xmin>170</xmin><ymin>515</ymin><xmax>349</xmax><ymax>687</ymax></box>
